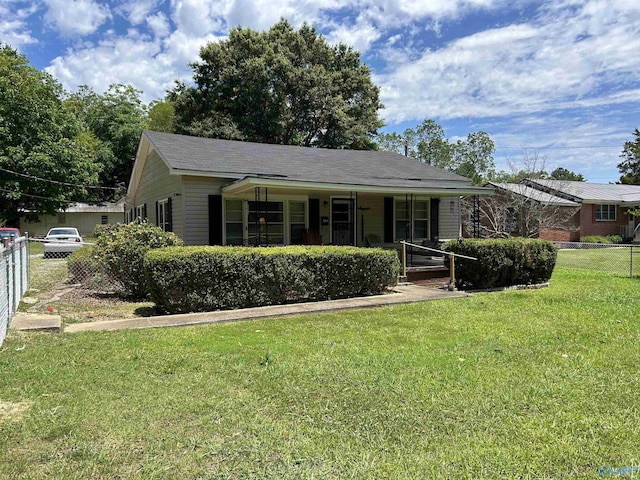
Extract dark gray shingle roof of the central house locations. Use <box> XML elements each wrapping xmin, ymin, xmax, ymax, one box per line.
<box><xmin>143</xmin><ymin>131</ymin><xmax>478</xmax><ymax>188</ymax></box>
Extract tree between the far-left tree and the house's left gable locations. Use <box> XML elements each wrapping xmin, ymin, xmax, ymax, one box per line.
<box><xmin>67</xmin><ymin>84</ymin><xmax>148</xmax><ymax>199</ymax></box>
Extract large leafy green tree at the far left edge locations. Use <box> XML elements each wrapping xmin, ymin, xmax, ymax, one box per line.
<box><xmin>0</xmin><ymin>44</ymin><xmax>99</xmax><ymax>224</ymax></box>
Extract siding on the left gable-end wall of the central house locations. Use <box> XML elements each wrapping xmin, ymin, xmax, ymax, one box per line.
<box><xmin>127</xmin><ymin>151</ymin><xmax>184</xmax><ymax>238</ymax></box>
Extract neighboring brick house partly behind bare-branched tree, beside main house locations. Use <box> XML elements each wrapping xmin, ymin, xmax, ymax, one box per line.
<box><xmin>480</xmin><ymin>182</ymin><xmax>580</xmax><ymax>242</ymax></box>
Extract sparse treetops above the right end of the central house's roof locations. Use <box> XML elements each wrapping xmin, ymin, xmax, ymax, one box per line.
<box><xmin>377</xmin><ymin>119</ymin><xmax>495</xmax><ymax>185</ymax></box>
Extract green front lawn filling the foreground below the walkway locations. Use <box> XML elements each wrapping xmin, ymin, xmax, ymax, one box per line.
<box><xmin>0</xmin><ymin>270</ymin><xmax>640</xmax><ymax>479</ymax></box>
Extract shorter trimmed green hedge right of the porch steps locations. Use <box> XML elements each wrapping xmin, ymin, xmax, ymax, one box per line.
<box><xmin>442</xmin><ymin>238</ymin><xmax>558</xmax><ymax>289</ymax></box>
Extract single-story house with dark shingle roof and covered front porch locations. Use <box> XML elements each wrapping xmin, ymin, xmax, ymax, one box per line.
<box><xmin>125</xmin><ymin>131</ymin><xmax>492</xmax><ymax>251</ymax></box>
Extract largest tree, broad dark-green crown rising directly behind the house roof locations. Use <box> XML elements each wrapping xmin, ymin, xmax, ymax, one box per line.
<box><xmin>169</xmin><ymin>20</ymin><xmax>382</xmax><ymax>149</ymax></box>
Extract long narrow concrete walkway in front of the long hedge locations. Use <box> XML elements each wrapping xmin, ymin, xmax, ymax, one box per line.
<box><xmin>64</xmin><ymin>284</ymin><xmax>469</xmax><ymax>333</ymax></box>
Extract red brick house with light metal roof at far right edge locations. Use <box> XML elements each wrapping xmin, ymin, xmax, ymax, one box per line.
<box><xmin>523</xmin><ymin>179</ymin><xmax>640</xmax><ymax>241</ymax></box>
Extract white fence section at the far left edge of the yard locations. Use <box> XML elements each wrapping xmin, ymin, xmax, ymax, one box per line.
<box><xmin>0</xmin><ymin>237</ymin><xmax>29</xmax><ymax>347</ymax></box>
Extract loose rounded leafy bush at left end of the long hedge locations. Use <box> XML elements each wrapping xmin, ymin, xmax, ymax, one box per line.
<box><xmin>95</xmin><ymin>222</ymin><xmax>182</xmax><ymax>298</ymax></box>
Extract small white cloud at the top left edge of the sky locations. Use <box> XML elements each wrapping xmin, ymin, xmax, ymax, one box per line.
<box><xmin>44</xmin><ymin>0</ymin><xmax>111</xmax><ymax>37</ymax></box>
